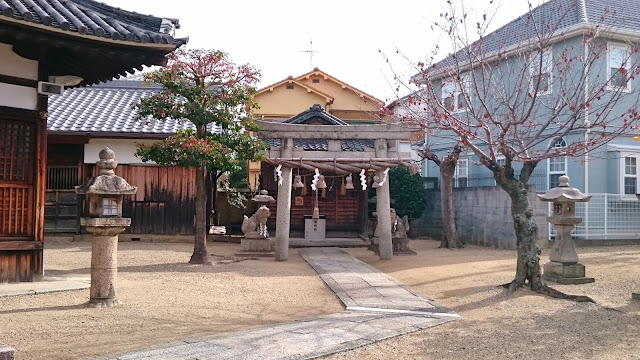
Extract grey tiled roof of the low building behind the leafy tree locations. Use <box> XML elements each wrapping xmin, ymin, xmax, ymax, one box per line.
<box><xmin>46</xmin><ymin>80</ymin><xmax>215</xmax><ymax>134</ymax></box>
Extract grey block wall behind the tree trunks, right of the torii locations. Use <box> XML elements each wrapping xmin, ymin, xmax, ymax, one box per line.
<box><xmin>411</xmin><ymin>187</ymin><xmax>549</xmax><ymax>249</ymax></box>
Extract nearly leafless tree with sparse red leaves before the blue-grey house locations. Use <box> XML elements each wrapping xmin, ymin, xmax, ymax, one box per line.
<box><xmin>388</xmin><ymin>0</ymin><xmax>640</xmax><ymax>300</ymax></box>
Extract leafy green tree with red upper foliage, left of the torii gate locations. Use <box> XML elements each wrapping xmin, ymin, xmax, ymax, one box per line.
<box><xmin>135</xmin><ymin>49</ymin><xmax>265</xmax><ymax>264</ymax></box>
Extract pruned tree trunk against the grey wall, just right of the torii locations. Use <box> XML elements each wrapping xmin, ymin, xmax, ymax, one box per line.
<box><xmin>439</xmin><ymin>160</ymin><xmax>463</xmax><ymax>249</ymax></box>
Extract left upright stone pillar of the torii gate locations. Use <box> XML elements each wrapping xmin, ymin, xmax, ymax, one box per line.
<box><xmin>275</xmin><ymin>139</ymin><xmax>293</xmax><ymax>261</ymax></box>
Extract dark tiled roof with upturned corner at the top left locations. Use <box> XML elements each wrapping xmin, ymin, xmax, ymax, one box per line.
<box><xmin>0</xmin><ymin>0</ymin><xmax>187</xmax><ymax>46</ymax></box>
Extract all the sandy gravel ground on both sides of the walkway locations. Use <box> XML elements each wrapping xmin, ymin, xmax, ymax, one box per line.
<box><xmin>0</xmin><ymin>240</ymin><xmax>640</xmax><ymax>360</ymax></box>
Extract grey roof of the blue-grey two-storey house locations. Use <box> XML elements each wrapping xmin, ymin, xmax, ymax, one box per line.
<box><xmin>424</xmin><ymin>0</ymin><xmax>640</xmax><ymax>82</ymax></box>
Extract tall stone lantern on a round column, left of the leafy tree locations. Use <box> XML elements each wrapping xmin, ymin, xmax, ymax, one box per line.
<box><xmin>76</xmin><ymin>148</ymin><xmax>137</xmax><ymax>307</ymax></box>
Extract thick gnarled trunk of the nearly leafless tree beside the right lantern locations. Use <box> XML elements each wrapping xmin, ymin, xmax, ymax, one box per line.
<box><xmin>500</xmin><ymin>177</ymin><xmax>545</xmax><ymax>294</ymax></box>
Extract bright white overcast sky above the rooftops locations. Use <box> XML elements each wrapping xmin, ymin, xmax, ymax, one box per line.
<box><xmin>102</xmin><ymin>0</ymin><xmax>540</xmax><ymax>102</ymax></box>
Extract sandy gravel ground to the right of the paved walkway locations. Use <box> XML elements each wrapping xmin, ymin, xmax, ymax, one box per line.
<box><xmin>327</xmin><ymin>241</ymin><xmax>640</xmax><ymax>360</ymax></box>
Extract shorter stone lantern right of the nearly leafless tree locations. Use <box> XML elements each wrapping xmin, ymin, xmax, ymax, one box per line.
<box><xmin>538</xmin><ymin>176</ymin><xmax>595</xmax><ymax>284</ymax></box>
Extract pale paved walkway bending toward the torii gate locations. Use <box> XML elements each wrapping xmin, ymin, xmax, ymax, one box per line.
<box><xmin>100</xmin><ymin>248</ymin><xmax>459</xmax><ymax>360</ymax></box>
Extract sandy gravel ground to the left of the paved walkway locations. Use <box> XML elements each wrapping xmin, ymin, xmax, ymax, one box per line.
<box><xmin>0</xmin><ymin>242</ymin><xmax>343</xmax><ymax>360</ymax></box>
